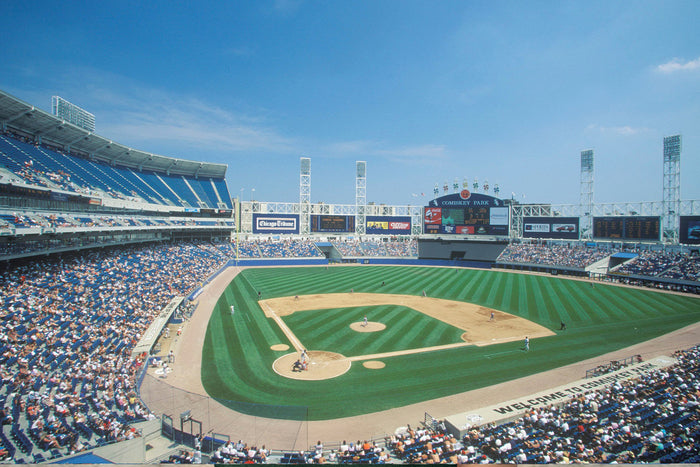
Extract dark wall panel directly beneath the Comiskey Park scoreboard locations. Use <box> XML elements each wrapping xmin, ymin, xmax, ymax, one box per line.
<box><xmin>418</xmin><ymin>237</ymin><xmax>508</xmax><ymax>263</ymax></box>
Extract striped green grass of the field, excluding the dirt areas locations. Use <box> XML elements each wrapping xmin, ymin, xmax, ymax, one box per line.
<box><xmin>202</xmin><ymin>266</ymin><xmax>700</xmax><ymax>420</ymax></box>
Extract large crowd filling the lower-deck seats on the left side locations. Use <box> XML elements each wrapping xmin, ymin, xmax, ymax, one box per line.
<box><xmin>0</xmin><ymin>243</ymin><xmax>237</xmax><ymax>461</ymax></box>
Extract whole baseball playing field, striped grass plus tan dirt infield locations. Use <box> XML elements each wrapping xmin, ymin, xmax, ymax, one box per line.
<box><xmin>201</xmin><ymin>266</ymin><xmax>700</xmax><ymax>420</ymax></box>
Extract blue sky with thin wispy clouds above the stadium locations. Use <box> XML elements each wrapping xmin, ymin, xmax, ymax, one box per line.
<box><xmin>0</xmin><ymin>0</ymin><xmax>700</xmax><ymax>204</ymax></box>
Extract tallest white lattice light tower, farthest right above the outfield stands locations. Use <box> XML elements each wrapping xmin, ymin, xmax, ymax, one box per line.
<box><xmin>662</xmin><ymin>135</ymin><xmax>681</xmax><ymax>244</ymax></box>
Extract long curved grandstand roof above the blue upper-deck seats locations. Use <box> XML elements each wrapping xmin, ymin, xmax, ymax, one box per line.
<box><xmin>0</xmin><ymin>90</ymin><xmax>228</xmax><ymax>178</ymax></box>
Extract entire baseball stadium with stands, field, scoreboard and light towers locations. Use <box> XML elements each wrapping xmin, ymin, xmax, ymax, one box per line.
<box><xmin>0</xmin><ymin>87</ymin><xmax>700</xmax><ymax>464</ymax></box>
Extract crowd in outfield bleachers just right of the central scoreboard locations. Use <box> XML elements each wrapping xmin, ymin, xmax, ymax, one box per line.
<box><xmin>496</xmin><ymin>243</ymin><xmax>612</xmax><ymax>269</ymax></box>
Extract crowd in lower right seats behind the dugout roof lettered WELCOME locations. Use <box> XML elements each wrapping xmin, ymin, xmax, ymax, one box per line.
<box><xmin>382</xmin><ymin>346</ymin><xmax>700</xmax><ymax>464</ymax></box>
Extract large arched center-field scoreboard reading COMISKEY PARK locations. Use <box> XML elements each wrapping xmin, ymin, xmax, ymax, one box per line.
<box><xmin>423</xmin><ymin>190</ymin><xmax>510</xmax><ymax>235</ymax></box>
